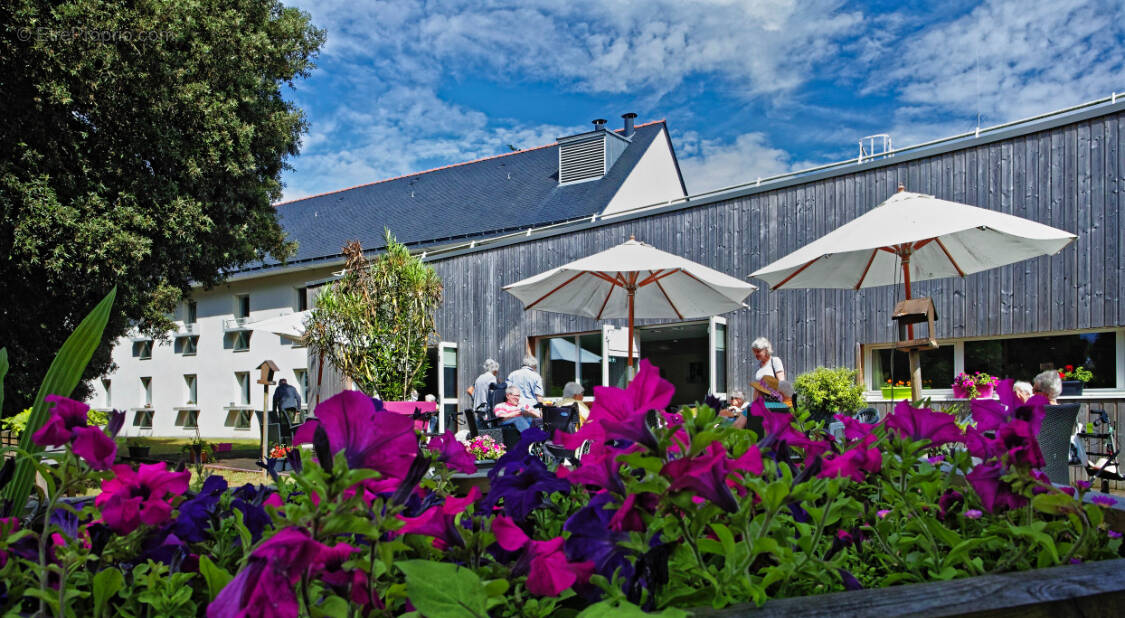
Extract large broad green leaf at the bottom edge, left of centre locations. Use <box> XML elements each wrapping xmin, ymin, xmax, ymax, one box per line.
<box><xmin>396</xmin><ymin>561</ymin><xmax>488</xmax><ymax>618</ymax></box>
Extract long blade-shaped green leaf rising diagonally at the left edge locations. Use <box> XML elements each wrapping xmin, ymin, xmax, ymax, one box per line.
<box><xmin>5</xmin><ymin>287</ymin><xmax>117</xmax><ymax>504</ymax></box>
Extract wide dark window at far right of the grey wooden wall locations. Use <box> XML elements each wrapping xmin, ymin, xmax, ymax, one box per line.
<box><xmin>964</xmin><ymin>331</ymin><xmax>1119</xmax><ymax>388</ymax></box>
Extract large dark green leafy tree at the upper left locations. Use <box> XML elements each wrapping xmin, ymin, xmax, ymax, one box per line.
<box><xmin>0</xmin><ymin>0</ymin><xmax>324</xmax><ymax>413</ymax></box>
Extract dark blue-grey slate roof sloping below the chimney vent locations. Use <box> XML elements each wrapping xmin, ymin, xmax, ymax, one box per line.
<box><xmin>242</xmin><ymin>120</ymin><xmax>664</xmax><ymax>271</ymax></box>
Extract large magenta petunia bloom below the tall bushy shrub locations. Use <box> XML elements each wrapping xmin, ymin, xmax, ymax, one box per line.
<box><xmin>294</xmin><ymin>391</ymin><xmax>417</xmax><ymax>480</ymax></box>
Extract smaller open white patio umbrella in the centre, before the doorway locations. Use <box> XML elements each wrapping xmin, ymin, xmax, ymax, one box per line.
<box><xmin>504</xmin><ymin>236</ymin><xmax>757</xmax><ymax>368</ymax></box>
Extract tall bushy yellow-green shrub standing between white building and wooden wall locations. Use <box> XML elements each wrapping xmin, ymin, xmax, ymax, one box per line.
<box><xmin>305</xmin><ymin>230</ymin><xmax>442</xmax><ymax>400</ymax></box>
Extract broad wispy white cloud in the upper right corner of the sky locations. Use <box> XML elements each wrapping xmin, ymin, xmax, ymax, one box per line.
<box><xmin>864</xmin><ymin>0</ymin><xmax>1125</xmax><ymax>125</ymax></box>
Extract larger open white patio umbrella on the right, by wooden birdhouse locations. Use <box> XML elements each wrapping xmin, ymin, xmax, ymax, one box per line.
<box><xmin>750</xmin><ymin>186</ymin><xmax>1078</xmax><ymax>398</ymax></box>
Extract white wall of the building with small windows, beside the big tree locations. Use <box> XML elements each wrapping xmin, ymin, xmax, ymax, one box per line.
<box><xmin>89</xmin><ymin>267</ymin><xmax>338</xmax><ymax>439</ymax></box>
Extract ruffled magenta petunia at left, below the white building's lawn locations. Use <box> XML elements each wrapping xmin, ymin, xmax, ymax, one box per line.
<box><xmin>93</xmin><ymin>464</ymin><xmax>191</xmax><ymax>534</ymax></box>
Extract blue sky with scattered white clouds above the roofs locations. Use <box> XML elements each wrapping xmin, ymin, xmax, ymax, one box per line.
<box><xmin>284</xmin><ymin>0</ymin><xmax>1125</xmax><ymax>199</ymax></box>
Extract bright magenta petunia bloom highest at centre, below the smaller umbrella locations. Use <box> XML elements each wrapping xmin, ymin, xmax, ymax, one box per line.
<box><xmin>586</xmin><ymin>359</ymin><xmax>675</xmax><ymax>448</ymax></box>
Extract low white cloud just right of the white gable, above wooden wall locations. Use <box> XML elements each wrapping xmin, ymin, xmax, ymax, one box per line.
<box><xmin>675</xmin><ymin>131</ymin><xmax>797</xmax><ymax>195</ymax></box>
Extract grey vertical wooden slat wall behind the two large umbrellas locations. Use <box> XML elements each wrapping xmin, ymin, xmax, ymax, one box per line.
<box><xmin>432</xmin><ymin>113</ymin><xmax>1125</xmax><ymax>436</ymax></box>
